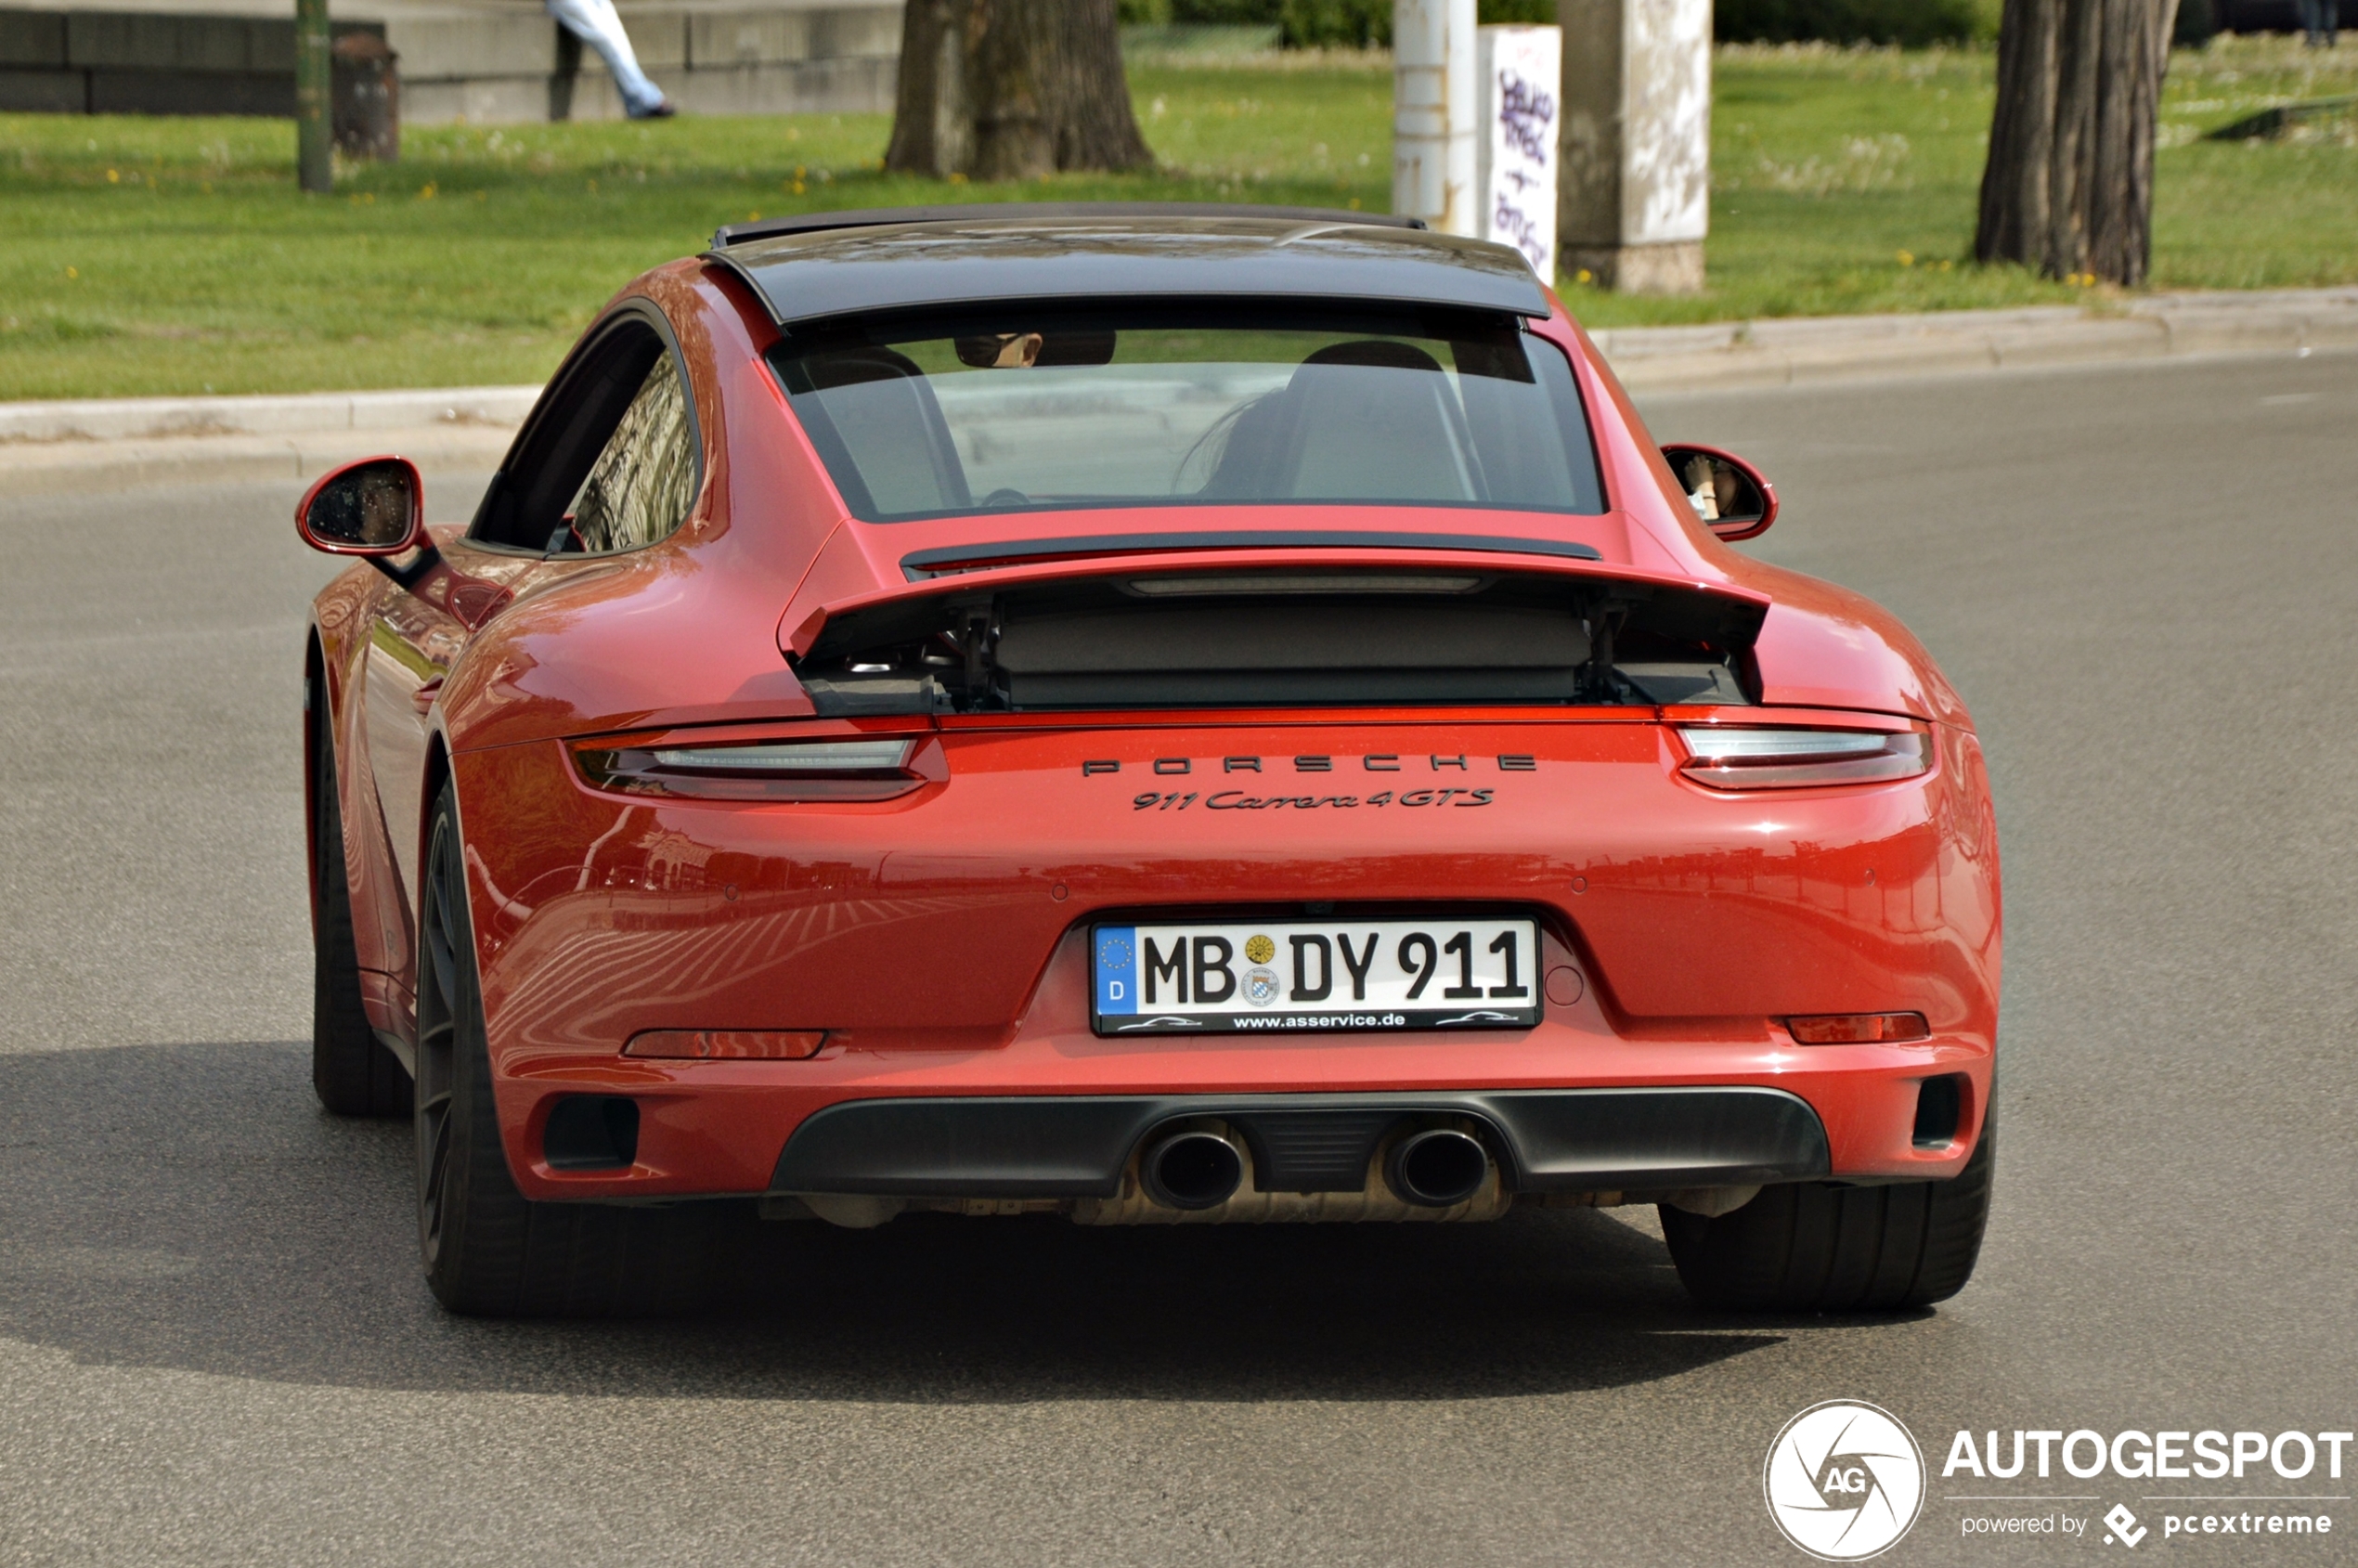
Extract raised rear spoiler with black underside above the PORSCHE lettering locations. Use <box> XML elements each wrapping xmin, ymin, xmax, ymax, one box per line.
<box><xmin>778</xmin><ymin>547</ymin><xmax>1768</xmax><ymax>717</ymax></box>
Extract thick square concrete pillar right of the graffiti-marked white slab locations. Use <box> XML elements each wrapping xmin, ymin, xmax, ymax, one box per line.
<box><xmin>1556</xmin><ymin>0</ymin><xmax>1712</xmax><ymax>294</ymax></box>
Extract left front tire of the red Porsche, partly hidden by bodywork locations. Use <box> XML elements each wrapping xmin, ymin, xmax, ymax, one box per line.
<box><xmin>309</xmin><ymin>674</ymin><xmax>410</xmax><ymax>1115</ymax></box>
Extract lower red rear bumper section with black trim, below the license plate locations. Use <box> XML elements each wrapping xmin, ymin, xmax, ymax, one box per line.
<box><xmin>498</xmin><ymin>1014</ymin><xmax>1992</xmax><ymax>1200</ymax></box>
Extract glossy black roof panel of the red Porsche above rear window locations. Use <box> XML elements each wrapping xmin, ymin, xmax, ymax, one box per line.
<box><xmin>707</xmin><ymin>202</ymin><xmax>1549</xmax><ymax>325</ymax></box>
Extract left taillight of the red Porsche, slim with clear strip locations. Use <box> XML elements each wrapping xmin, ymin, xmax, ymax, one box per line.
<box><xmin>573</xmin><ymin>735</ymin><xmax>939</xmax><ymax>802</ymax></box>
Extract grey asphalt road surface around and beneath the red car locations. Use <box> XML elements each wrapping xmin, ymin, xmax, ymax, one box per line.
<box><xmin>0</xmin><ymin>356</ymin><xmax>2358</xmax><ymax>1568</ymax></box>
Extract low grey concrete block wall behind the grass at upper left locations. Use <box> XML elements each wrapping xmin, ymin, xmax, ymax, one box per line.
<box><xmin>0</xmin><ymin>0</ymin><xmax>900</xmax><ymax>125</ymax></box>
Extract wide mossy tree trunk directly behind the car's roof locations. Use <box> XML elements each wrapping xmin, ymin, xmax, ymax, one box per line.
<box><xmin>885</xmin><ymin>0</ymin><xmax>1153</xmax><ymax>179</ymax></box>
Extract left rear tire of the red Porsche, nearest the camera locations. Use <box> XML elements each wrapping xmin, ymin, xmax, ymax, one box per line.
<box><xmin>418</xmin><ymin>785</ymin><xmax>712</xmax><ymax>1318</ymax></box>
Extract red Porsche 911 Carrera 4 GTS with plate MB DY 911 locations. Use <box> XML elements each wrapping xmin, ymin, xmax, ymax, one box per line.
<box><xmin>297</xmin><ymin>205</ymin><xmax>2000</xmax><ymax>1314</ymax></box>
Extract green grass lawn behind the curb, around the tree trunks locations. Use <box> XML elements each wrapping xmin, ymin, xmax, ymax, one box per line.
<box><xmin>0</xmin><ymin>40</ymin><xmax>2358</xmax><ymax>398</ymax></box>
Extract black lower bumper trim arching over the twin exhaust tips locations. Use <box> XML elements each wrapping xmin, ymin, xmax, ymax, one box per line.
<box><xmin>771</xmin><ymin>1089</ymin><xmax>1830</xmax><ymax>1198</ymax></box>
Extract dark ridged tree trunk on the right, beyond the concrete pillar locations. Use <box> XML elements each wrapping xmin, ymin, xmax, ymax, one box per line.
<box><xmin>1974</xmin><ymin>0</ymin><xmax>2179</xmax><ymax>285</ymax></box>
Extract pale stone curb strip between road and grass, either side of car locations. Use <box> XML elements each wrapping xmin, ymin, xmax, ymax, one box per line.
<box><xmin>0</xmin><ymin>288</ymin><xmax>2358</xmax><ymax>495</ymax></box>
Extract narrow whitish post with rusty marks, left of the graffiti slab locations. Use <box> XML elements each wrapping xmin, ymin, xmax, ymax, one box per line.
<box><xmin>1392</xmin><ymin>0</ymin><xmax>1481</xmax><ymax>233</ymax></box>
